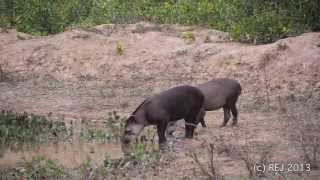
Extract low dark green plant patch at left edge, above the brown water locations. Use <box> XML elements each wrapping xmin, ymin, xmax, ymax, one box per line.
<box><xmin>0</xmin><ymin>110</ymin><xmax>67</xmax><ymax>145</ymax></box>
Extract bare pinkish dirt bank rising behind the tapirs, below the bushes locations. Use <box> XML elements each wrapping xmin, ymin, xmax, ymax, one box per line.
<box><xmin>0</xmin><ymin>23</ymin><xmax>320</xmax><ymax>116</ymax></box>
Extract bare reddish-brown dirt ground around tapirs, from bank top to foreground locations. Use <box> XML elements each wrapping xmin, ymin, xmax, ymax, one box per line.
<box><xmin>0</xmin><ymin>23</ymin><xmax>320</xmax><ymax>179</ymax></box>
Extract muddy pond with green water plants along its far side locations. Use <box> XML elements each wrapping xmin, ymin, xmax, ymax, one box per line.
<box><xmin>0</xmin><ymin>111</ymin><xmax>127</xmax><ymax>169</ymax></box>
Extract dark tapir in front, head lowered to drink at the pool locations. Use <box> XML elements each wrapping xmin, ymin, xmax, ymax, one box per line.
<box><xmin>121</xmin><ymin>86</ymin><xmax>204</xmax><ymax>152</ymax></box>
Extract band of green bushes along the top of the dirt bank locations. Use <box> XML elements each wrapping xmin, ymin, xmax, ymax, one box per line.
<box><xmin>0</xmin><ymin>0</ymin><xmax>320</xmax><ymax>43</ymax></box>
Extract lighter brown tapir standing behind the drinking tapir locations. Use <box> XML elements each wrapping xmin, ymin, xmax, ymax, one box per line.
<box><xmin>167</xmin><ymin>78</ymin><xmax>242</xmax><ymax>134</ymax></box>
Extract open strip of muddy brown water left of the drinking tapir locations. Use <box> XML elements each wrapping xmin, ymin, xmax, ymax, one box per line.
<box><xmin>0</xmin><ymin>141</ymin><xmax>122</xmax><ymax>168</ymax></box>
